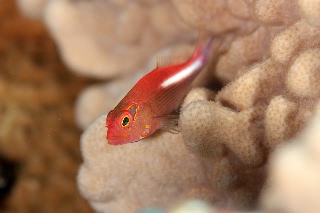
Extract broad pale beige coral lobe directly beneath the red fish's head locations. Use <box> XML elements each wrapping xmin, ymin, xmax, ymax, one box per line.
<box><xmin>78</xmin><ymin>115</ymin><xmax>215</xmax><ymax>213</ymax></box>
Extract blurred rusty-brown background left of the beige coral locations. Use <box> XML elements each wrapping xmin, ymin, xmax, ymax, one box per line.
<box><xmin>0</xmin><ymin>1</ymin><xmax>92</xmax><ymax>212</ymax></box>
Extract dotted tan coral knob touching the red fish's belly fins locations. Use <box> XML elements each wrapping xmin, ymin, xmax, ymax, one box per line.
<box><xmin>180</xmin><ymin>101</ymin><xmax>263</xmax><ymax>165</ymax></box>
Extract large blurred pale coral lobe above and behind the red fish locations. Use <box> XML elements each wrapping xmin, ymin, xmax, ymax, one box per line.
<box><xmin>20</xmin><ymin>0</ymin><xmax>195</xmax><ymax>78</ymax></box>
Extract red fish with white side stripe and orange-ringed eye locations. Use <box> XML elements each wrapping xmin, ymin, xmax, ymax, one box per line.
<box><xmin>106</xmin><ymin>37</ymin><xmax>218</xmax><ymax>145</ymax></box>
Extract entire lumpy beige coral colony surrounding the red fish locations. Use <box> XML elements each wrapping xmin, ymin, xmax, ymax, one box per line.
<box><xmin>17</xmin><ymin>0</ymin><xmax>320</xmax><ymax>213</ymax></box>
